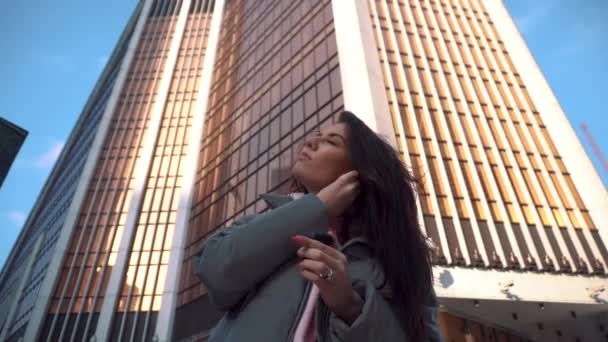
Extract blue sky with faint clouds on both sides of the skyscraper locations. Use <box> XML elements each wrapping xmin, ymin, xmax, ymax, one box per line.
<box><xmin>0</xmin><ymin>0</ymin><xmax>608</xmax><ymax>265</ymax></box>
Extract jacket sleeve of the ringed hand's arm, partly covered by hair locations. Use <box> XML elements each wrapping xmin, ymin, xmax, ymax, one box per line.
<box><xmin>329</xmin><ymin>281</ymin><xmax>443</xmax><ymax>342</ymax></box>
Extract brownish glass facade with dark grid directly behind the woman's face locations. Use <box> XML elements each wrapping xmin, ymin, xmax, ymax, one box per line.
<box><xmin>175</xmin><ymin>0</ymin><xmax>343</xmax><ymax>337</ymax></box>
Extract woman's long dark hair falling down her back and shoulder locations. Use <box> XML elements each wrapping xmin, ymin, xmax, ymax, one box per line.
<box><xmin>290</xmin><ymin>111</ymin><xmax>432</xmax><ymax>341</ymax></box>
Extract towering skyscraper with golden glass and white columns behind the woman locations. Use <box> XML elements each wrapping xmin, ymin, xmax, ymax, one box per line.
<box><xmin>0</xmin><ymin>0</ymin><xmax>608</xmax><ymax>341</ymax></box>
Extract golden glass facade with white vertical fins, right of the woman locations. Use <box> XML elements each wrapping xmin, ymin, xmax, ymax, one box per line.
<box><xmin>368</xmin><ymin>0</ymin><xmax>608</xmax><ymax>273</ymax></box>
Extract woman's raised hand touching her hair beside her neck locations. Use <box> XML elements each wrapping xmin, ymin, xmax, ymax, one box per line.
<box><xmin>317</xmin><ymin>171</ymin><xmax>359</xmax><ymax>217</ymax></box>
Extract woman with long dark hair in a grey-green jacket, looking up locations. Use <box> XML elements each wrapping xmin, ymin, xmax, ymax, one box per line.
<box><xmin>194</xmin><ymin>112</ymin><xmax>441</xmax><ymax>342</ymax></box>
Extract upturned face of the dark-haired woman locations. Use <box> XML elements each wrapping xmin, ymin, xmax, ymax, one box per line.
<box><xmin>291</xmin><ymin>123</ymin><xmax>353</xmax><ymax>193</ymax></box>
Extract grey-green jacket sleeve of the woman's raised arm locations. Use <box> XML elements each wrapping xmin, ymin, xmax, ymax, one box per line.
<box><xmin>193</xmin><ymin>194</ymin><xmax>328</xmax><ymax>311</ymax></box>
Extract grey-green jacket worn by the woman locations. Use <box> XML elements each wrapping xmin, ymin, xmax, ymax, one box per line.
<box><xmin>194</xmin><ymin>194</ymin><xmax>441</xmax><ymax>342</ymax></box>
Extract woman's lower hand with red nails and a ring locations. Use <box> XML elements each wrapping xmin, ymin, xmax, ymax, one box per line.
<box><xmin>292</xmin><ymin>235</ymin><xmax>363</xmax><ymax>324</ymax></box>
